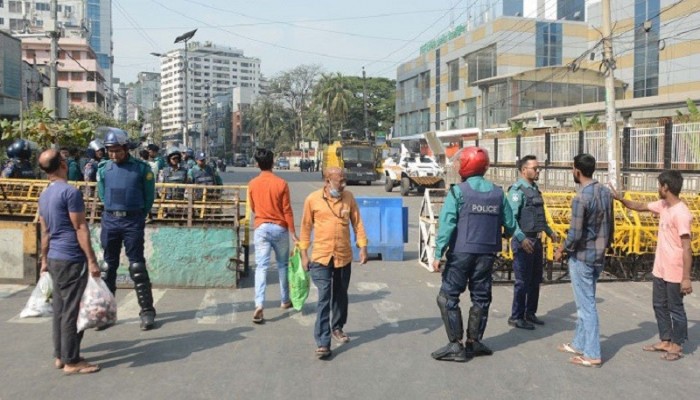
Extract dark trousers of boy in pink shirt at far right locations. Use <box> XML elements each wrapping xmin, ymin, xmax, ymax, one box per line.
<box><xmin>651</xmin><ymin>277</ymin><xmax>688</xmax><ymax>344</ymax></box>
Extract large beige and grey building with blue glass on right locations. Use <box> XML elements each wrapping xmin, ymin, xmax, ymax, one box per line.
<box><xmin>394</xmin><ymin>0</ymin><xmax>700</xmax><ymax>137</ymax></box>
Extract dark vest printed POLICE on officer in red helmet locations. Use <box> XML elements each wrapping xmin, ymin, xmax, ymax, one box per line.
<box><xmin>452</xmin><ymin>182</ymin><xmax>503</xmax><ymax>254</ymax></box>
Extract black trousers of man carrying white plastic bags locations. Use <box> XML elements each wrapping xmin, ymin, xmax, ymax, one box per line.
<box><xmin>48</xmin><ymin>259</ymin><xmax>88</xmax><ymax>364</ymax></box>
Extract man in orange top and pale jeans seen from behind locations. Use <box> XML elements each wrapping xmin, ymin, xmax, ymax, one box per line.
<box><xmin>248</xmin><ymin>149</ymin><xmax>298</xmax><ymax>324</ymax></box>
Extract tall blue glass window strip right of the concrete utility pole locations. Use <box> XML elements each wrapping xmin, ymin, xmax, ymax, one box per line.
<box><xmin>633</xmin><ymin>0</ymin><xmax>661</xmax><ymax>97</ymax></box>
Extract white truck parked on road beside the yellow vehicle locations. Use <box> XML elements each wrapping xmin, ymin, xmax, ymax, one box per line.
<box><xmin>383</xmin><ymin>145</ymin><xmax>445</xmax><ymax>196</ymax></box>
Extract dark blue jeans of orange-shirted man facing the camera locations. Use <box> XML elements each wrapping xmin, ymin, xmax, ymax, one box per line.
<box><xmin>309</xmin><ymin>259</ymin><xmax>352</xmax><ymax>348</ymax></box>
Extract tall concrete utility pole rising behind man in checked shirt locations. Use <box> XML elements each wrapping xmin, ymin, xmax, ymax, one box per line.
<box><xmin>601</xmin><ymin>0</ymin><xmax>622</xmax><ymax>190</ymax></box>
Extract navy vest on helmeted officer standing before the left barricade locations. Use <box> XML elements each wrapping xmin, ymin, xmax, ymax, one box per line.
<box><xmin>102</xmin><ymin>160</ymin><xmax>145</xmax><ymax>211</ymax></box>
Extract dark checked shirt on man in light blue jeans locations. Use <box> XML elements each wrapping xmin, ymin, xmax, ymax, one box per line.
<box><xmin>564</xmin><ymin>180</ymin><xmax>615</xmax><ymax>266</ymax></box>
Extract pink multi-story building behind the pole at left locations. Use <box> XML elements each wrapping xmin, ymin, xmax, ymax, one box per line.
<box><xmin>22</xmin><ymin>38</ymin><xmax>106</xmax><ymax>110</ymax></box>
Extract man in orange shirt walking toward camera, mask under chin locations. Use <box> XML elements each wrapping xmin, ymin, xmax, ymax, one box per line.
<box><xmin>298</xmin><ymin>167</ymin><xmax>367</xmax><ymax>358</ymax></box>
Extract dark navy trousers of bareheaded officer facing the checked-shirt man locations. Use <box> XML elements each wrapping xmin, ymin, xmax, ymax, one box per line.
<box><xmin>510</xmin><ymin>239</ymin><xmax>544</xmax><ymax>319</ymax></box>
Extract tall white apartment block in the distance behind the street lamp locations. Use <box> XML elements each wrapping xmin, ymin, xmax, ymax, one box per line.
<box><xmin>160</xmin><ymin>42</ymin><xmax>260</xmax><ymax>143</ymax></box>
